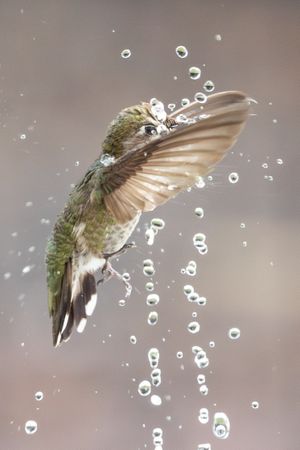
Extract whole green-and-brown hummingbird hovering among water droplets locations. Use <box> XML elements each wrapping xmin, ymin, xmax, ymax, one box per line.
<box><xmin>46</xmin><ymin>91</ymin><xmax>250</xmax><ymax>347</ymax></box>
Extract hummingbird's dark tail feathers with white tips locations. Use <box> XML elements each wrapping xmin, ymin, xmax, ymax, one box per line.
<box><xmin>52</xmin><ymin>258</ymin><xmax>97</xmax><ymax>347</ymax></box>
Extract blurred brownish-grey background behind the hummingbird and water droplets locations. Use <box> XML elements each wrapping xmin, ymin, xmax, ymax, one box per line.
<box><xmin>0</xmin><ymin>0</ymin><xmax>300</xmax><ymax>450</ymax></box>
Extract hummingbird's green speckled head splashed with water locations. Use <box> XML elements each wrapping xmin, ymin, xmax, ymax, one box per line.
<box><xmin>102</xmin><ymin>99</ymin><xmax>176</xmax><ymax>158</ymax></box>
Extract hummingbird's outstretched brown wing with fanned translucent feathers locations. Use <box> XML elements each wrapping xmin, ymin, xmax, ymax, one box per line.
<box><xmin>101</xmin><ymin>91</ymin><xmax>249</xmax><ymax>223</ymax></box>
